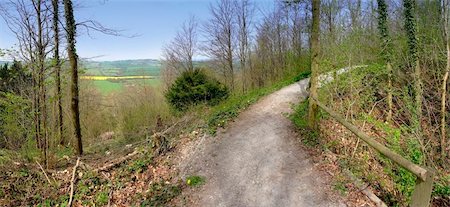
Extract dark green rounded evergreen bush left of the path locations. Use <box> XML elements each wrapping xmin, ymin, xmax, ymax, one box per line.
<box><xmin>166</xmin><ymin>70</ymin><xmax>229</xmax><ymax>111</ymax></box>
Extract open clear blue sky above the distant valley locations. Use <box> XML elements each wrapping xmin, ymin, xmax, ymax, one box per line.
<box><xmin>0</xmin><ymin>0</ymin><xmax>273</xmax><ymax>60</ymax></box>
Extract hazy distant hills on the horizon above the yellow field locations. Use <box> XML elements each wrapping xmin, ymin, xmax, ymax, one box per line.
<box><xmin>81</xmin><ymin>59</ymin><xmax>161</xmax><ymax>76</ymax></box>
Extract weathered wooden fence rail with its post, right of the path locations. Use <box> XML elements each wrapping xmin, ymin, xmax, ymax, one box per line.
<box><xmin>310</xmin><ymin>97</ymin><xmax>434</xmax><ymax>207</ymax></box>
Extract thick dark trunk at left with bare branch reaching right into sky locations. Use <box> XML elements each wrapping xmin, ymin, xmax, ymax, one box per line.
<box><xmin>64</xmin><ymin>0</ymin><xmax>83</xmax><ymax>155</ymax></box>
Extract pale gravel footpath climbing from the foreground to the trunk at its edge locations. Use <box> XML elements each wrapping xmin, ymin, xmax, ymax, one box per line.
<box><xmin>180</xmin><ymin>80</ymin><xmax>345</xmax><ymax>207</ymax></box>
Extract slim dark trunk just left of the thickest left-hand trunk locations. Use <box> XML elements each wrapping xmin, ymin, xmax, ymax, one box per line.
<box><xmin>52</xmin><ymin>0</ymin><xmax>65</xmax><ymax>145</ymax></box>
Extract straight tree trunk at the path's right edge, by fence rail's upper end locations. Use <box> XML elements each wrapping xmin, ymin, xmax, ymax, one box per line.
<box><xmin>308</xmin><ymin>0</ymin><xmax>320</xmax><ymax>129</ymax></box>
